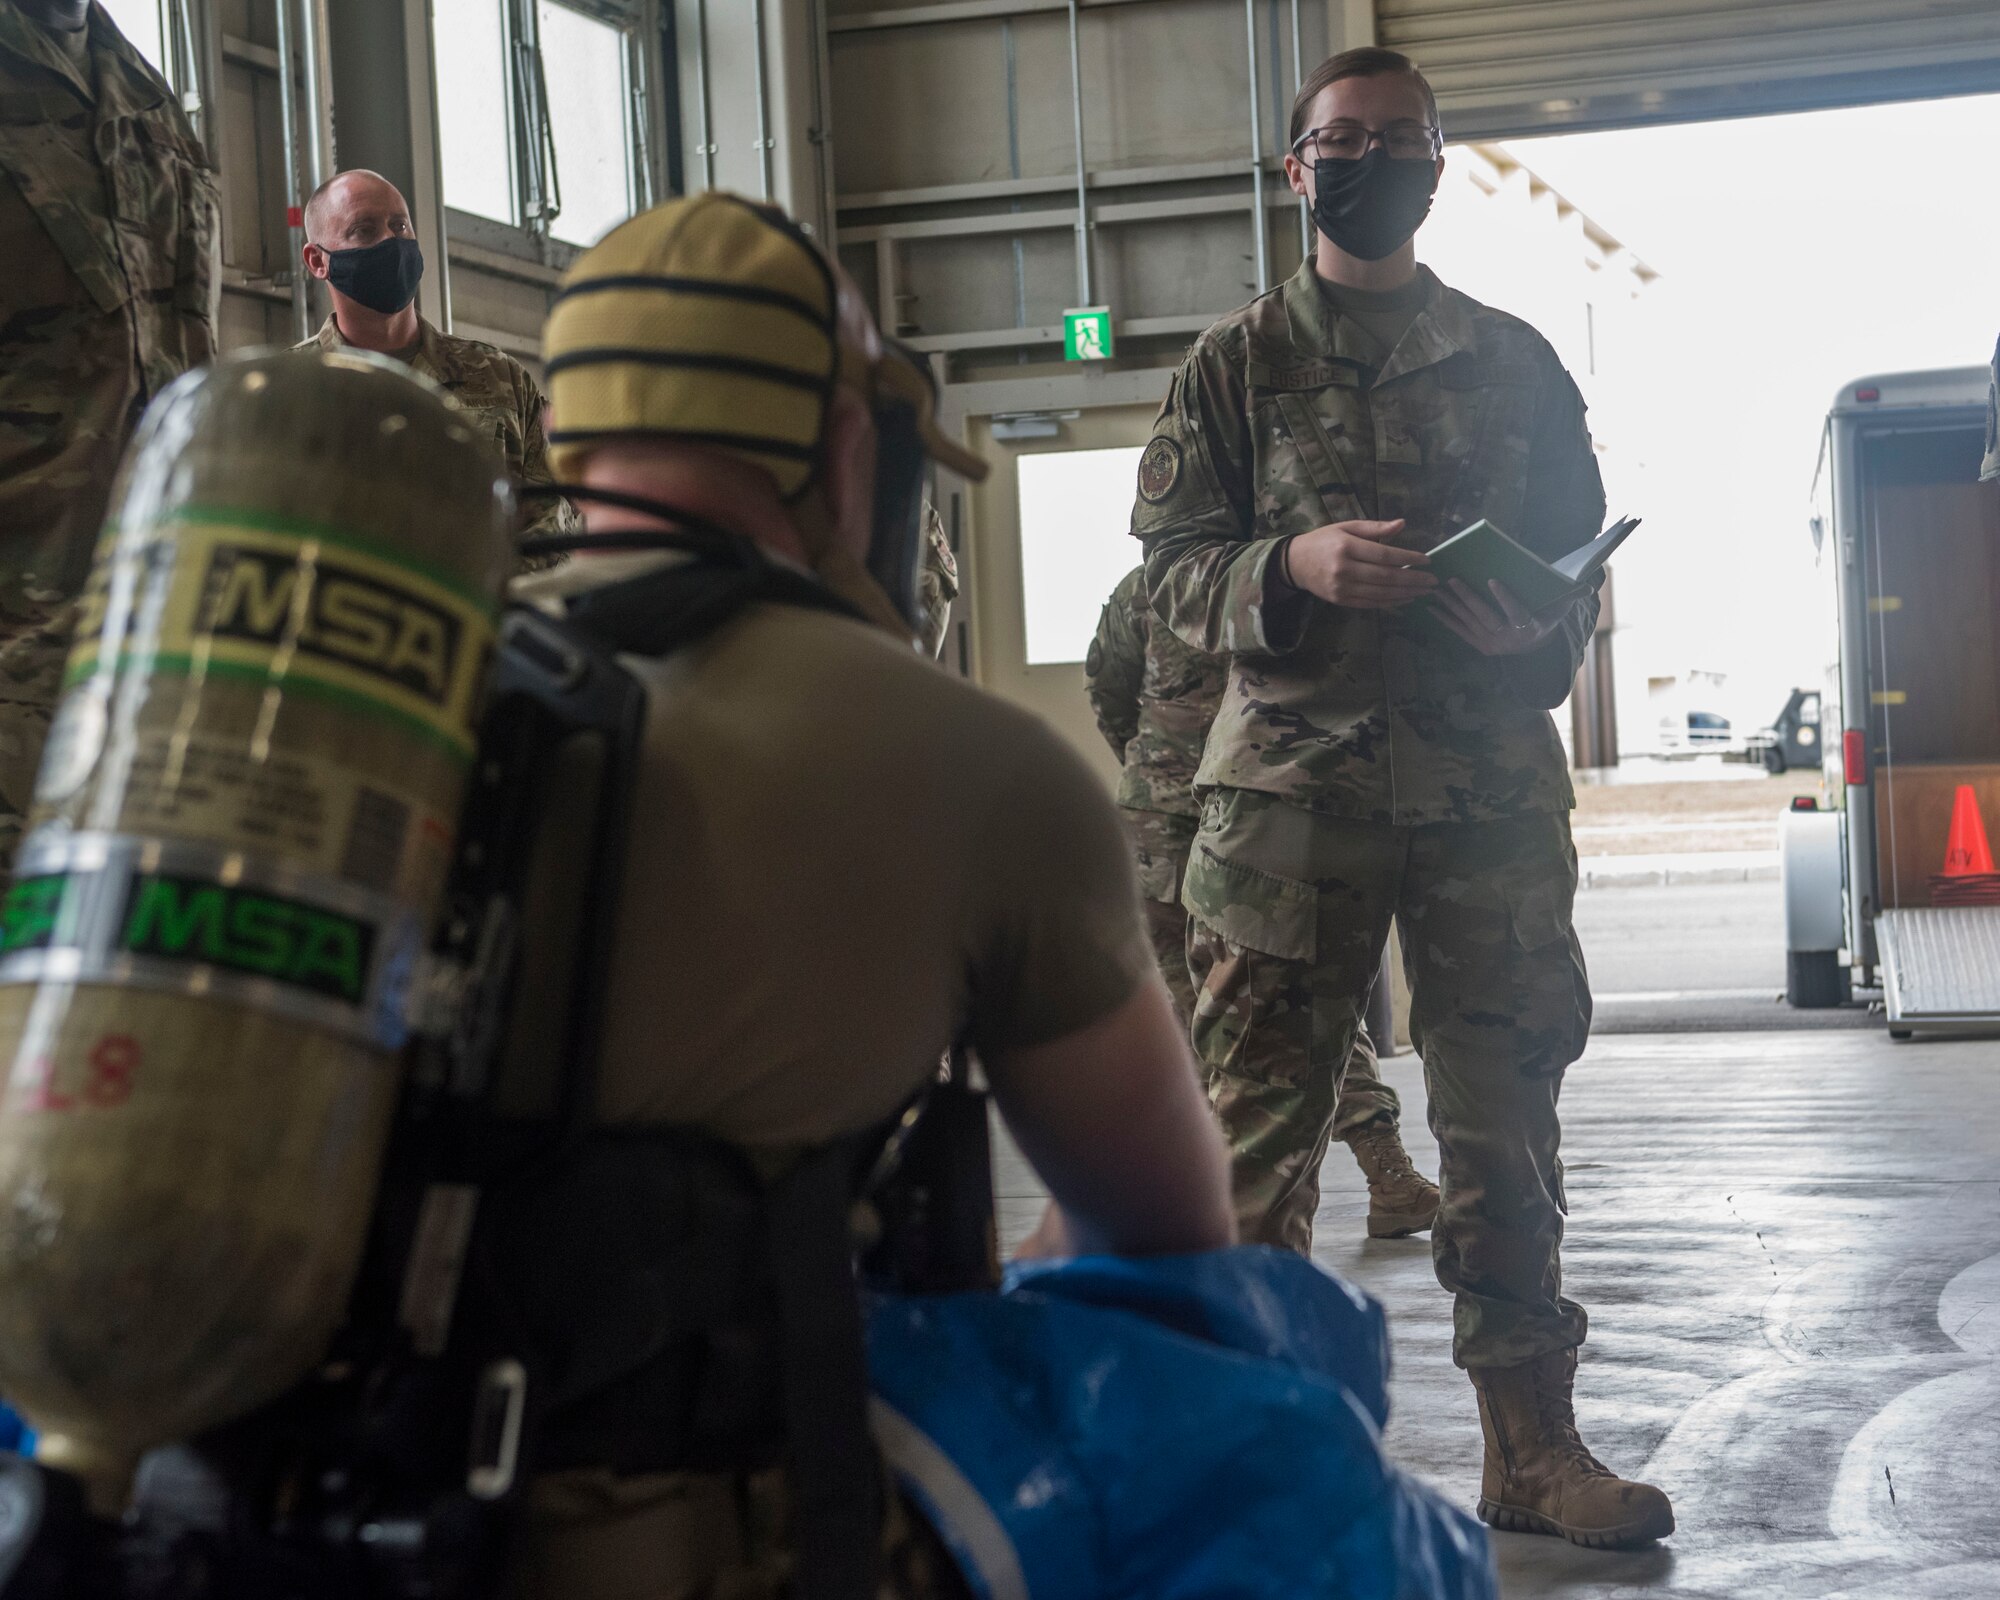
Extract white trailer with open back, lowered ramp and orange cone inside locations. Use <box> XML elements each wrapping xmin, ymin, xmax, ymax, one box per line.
<box><xmin>1780</xmin><ymin>368</ymin><xmax>2000</xmax><ymax>1038</ymax></box>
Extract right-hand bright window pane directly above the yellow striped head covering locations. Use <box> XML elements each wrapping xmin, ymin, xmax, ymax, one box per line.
<box><xmin>540</xmin><ymin>0</ymin><xmax>632</xmax><ymax>244</ymax></box>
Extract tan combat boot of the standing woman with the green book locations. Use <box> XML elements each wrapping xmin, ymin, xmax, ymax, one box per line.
<box><xmin>1468</xmin><ymin>1350</ymin><xmax>1674</xmax><ymax>1550</ymax></box>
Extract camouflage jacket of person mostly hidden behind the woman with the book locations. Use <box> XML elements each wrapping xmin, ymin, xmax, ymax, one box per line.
<box><xmin>1084</xmin><ymin>568</ymin><xmax>1228</xmax><ymax>818</ymax></box>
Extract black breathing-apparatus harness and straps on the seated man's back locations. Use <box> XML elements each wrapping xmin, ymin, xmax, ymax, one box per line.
<box><xmin>0</xmin><ymin>534</ymin><xmax>994</xmax><ymax>1600</ymax></box>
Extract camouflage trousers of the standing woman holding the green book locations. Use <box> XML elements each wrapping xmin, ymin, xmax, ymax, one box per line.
<box><xmin>1184</xmin><ymin>790</ymin><xmax>1590</xmax><ymax>1366</ymax></box>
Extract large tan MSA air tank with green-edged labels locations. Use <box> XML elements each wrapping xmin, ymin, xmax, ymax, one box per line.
<box><xmin>0</xmin><ymin>352</ymin><xmax>514</xmax><ymax>1510</ymax></box>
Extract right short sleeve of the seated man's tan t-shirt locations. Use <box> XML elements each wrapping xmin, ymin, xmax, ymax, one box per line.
<box><xmin>970</xmin><ymin>718</ymin><xmax>1154</xmax><ymax>1052</ymax></box>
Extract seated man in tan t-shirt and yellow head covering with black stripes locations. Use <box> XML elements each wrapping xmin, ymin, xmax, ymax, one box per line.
<box><xmin>516</xmin><ymin>196</ymin><xmax>1232</xmax><ymax>1600</ymax></box>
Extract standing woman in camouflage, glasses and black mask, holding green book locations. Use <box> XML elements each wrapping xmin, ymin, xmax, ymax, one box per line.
<box><xmin>1132</xmin><ymin>48</ymin><xmax>1674</xmax><ymax>1546</ymax></box>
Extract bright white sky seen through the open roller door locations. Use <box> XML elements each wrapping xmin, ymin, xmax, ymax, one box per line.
<box><xmin>1418</xmin><ymin>96</ymin><xmax>2000</xmax><ymax>728</ymax></box>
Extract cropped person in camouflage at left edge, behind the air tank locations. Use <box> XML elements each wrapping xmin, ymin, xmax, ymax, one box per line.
<box><xmin>0</xmin><ymin>0</ymin><xmax>218</xmax><ymax>874</ymax></box>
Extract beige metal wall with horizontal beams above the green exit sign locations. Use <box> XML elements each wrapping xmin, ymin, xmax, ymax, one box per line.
<box><xmin>828</xmin><ymin>0</ymin><xmax>1330</xmax><ymax>378</ymax></box>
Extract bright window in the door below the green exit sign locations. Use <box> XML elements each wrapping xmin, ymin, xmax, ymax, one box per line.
<box><xmin>1020</xmin><ymin>448</ymin><xmax>1144</xmax><ymax>666</ymax></box>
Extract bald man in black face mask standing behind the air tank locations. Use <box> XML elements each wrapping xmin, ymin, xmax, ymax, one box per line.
<box><xmin>302</xmin><ymin>168</ymin><xmax>582</xmax><ymax>556</ymax></box>
